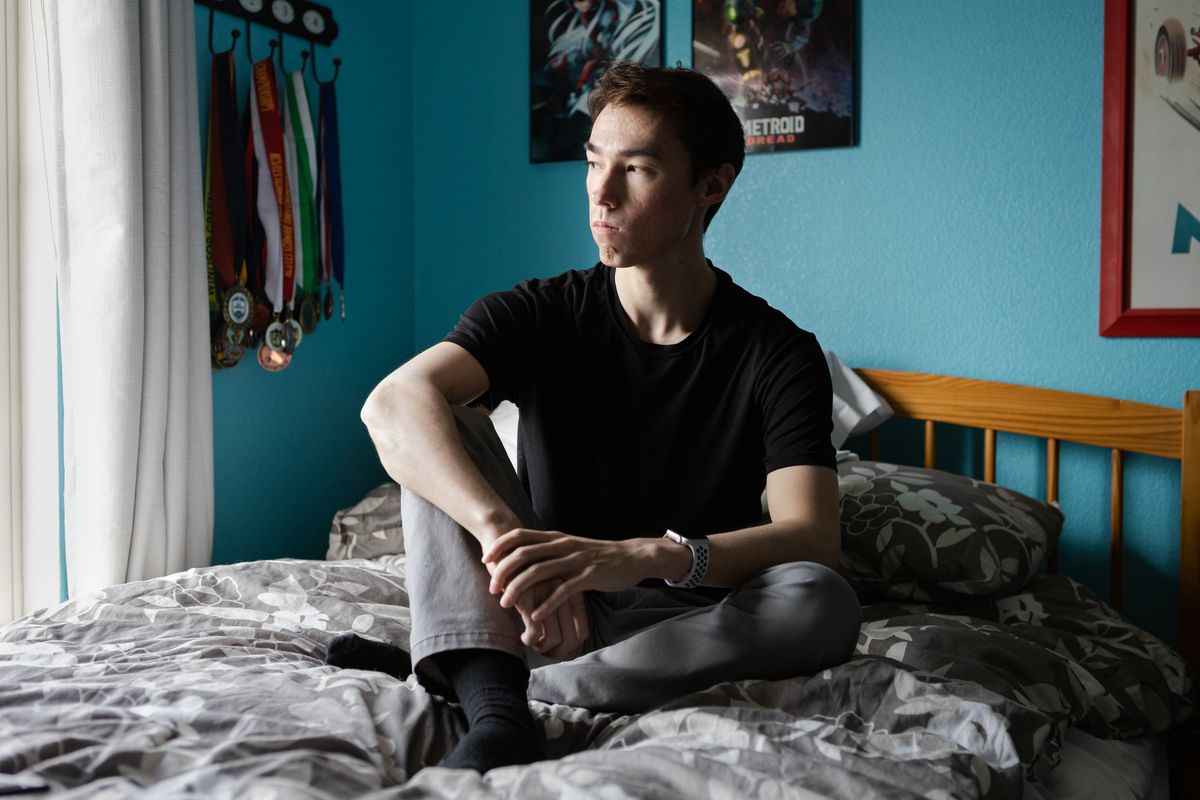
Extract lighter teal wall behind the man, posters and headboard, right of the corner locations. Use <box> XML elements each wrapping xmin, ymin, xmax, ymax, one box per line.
<box><xmin>413</xmin><ymin>0</ymin><xmax>1200</xmax><ymax>638</ymax></box>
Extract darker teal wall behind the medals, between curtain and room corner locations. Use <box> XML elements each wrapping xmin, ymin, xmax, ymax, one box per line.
<box><xmin>196</xmin><ymin>0</ymin><xmax>414</xmax><ymax>564</ymax></box>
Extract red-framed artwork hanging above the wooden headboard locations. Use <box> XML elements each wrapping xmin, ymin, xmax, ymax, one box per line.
<box><xmin>1100</xmin><ymin>0</ymin><xmax>1200</xmax><ymax>336</ymax></box>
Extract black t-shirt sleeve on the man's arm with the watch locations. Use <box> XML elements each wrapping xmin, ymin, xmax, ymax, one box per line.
<box><xmin>756</xmin><ymin>330</ymin><xmax>838</xmax><ymax>473</ymax></box>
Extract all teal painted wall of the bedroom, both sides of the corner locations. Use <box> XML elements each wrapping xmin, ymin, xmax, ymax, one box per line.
<box><xmin>197</xmin><ymin>0</ymin><xmax>1200</xmax><ymax>640</ymax></box>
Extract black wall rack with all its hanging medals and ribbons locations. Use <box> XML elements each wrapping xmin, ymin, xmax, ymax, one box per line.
<box><xmin>196</xmin><ymin>0</ymin><xmax>346</xmax><ymax>372</ymax></box>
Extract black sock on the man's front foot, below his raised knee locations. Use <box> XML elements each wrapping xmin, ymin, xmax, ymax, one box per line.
<box><xmin>434</xmin><ymin>649</ymin><xmax>546</xmax><ymax>772</ymax></box>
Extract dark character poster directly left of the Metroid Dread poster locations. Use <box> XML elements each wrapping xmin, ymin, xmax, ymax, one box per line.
<box><xmin>529</xmin><ymin>0</ymin><xmax>662</xmax><ymax>162</ymax></box>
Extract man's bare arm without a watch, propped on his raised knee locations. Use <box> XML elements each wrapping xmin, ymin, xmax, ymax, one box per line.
<box><xmin>361</xmin><ymin>342</ymin><xmax>521</xmax><ymax>547</ymax></box>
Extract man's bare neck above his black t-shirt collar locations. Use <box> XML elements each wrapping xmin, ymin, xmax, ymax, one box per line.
<box><xmin>613</xmin><ymin>251</ymin><xmax>716</xmax><ymax>344</ymax></box>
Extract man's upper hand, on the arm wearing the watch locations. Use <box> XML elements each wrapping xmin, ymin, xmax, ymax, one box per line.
<box><xmin>482</xmin><ymin>528</ymin><xmax>650</xmax><ymax>622</ymax></box>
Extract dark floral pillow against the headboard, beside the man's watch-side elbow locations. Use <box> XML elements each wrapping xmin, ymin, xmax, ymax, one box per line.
<box><xmin>838</xmin><ymin>461</ymin><xmax>1062</xmax><ymax>602</ymax></box>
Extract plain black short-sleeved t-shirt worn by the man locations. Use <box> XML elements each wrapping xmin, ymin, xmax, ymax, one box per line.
<box><xmin>445</xmin><ymin>264</ymin><xmax>835</xmax><ymax>540</ymax></box>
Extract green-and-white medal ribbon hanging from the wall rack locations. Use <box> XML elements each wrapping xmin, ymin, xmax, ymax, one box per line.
<box><xmin>283</xmin><ymin>70</ymin><xmax>318</xmax><ymax>294</ymax></box>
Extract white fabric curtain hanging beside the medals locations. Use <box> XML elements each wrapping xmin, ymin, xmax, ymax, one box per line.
<box><xmin>26</xmin><ymin>0</ymin><xmax>212</xmax><ymax>595</ymax></box>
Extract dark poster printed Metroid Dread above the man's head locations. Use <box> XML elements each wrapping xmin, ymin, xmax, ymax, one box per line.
<box><xmin>692</xmin><ymin>0</ymin><xmax>857</xmax><ymax>152</ymax></box>
